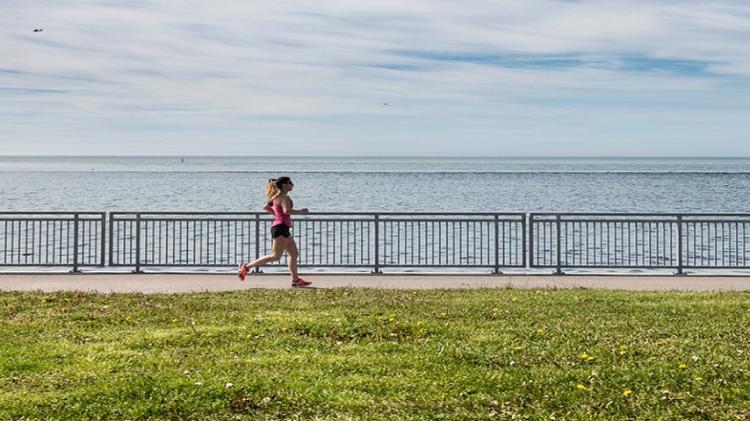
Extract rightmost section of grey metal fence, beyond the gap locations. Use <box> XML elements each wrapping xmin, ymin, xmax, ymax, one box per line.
<box><xmin>529</xmin><ymin>213</ymin><xmax>750</xmax><ymax>273</ymax></box>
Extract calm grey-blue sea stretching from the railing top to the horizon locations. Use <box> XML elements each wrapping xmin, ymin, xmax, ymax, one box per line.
<box><xmin>0</xmin><ymin>157</ymin><xmax>750</xmax><ymax>212</ymax></box>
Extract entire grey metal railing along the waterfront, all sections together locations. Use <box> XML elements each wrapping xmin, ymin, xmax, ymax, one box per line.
<box><xmin>0</xmin><ymin>212</ymin><xmax>750</xmax><ymax>274</ymax></box>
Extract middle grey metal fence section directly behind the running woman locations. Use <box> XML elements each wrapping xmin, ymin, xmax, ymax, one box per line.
<box><xmin>109</xmin><ymin>212</ymin><xmax>526</xmax><ymax>272</ymax></box>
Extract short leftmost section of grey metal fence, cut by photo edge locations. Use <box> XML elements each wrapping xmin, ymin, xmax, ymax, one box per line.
<box><xmin>0</xmin><ymin>212</ymin><xmax>106</xmax><ymax>271</ymax></box>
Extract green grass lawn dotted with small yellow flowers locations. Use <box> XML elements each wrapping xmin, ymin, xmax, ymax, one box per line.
<box><xmin>0</xmin><ymin>289</ymin><xmax>750</xmax><ymax>419</ymax></box>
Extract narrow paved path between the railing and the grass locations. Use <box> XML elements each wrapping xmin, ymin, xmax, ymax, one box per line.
<box><xmin>0</xmin><ymin>273</ymin><xmax>750</xmax><ymax>294</ymax></box>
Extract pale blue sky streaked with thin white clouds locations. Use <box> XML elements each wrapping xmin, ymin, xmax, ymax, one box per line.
<box><xmin>0</xmin><ymin>0</ymin><xmax>750</xmax><ymax>157</ymax></box>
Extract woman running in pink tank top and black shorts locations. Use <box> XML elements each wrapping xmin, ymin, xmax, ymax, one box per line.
<box><xmin>237</xmin><ymin>177</ymin><xmax>312</xmax><ymax>287</ymax></box>
